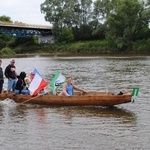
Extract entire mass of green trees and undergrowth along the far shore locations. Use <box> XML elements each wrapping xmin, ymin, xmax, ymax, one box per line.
<box><xmin>0</xmin><ymin>0</ymin><xmax>150</xmax><ymax>53</ymax></box>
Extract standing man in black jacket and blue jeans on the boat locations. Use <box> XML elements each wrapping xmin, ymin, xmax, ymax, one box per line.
<box><xmin>5</xmin><ymin>59</ymin><xmax>17</xmax><ymax>92</ymax></box>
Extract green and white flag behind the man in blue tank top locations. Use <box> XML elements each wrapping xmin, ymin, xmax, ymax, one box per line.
<box><xmin>50</xmin><ymin>71</ymin><xmax>66</xmax><ymax>94</ymax></box>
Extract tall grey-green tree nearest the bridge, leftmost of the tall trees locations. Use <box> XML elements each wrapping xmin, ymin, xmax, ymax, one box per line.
<box><xmin>41</xmin><ymin>0</ymin><xmax>73</xmax><ymax>41</ymax></box>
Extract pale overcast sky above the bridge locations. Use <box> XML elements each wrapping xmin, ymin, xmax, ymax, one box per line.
<box><xmin>0</xmin><ymin>0</ymin><xmax>50</xmax><ymax>25</ymax></box>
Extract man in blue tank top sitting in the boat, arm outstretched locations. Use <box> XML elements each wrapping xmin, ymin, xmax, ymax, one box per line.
<box><xmin>58</xmin><ymin>77</ymin><xmax>87</xmax><ymax>96</ymax></box>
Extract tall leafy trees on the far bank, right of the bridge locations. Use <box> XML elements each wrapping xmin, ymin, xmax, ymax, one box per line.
<box><xmin>41</xmin><ymin>0</ymin><xmax>150</xmax><ymax>51</ymax></box>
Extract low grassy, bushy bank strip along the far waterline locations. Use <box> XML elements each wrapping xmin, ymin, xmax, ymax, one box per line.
<box><xmin>0</xmin><ymin>39</ymin><xmax>150</xmax><ymax>57</ymax></box>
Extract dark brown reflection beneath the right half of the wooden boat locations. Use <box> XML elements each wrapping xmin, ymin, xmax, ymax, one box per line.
<box><xmin>52</xmin><ymin>107</ymin><xmax>134</xmax><ymax>119</ymax></box>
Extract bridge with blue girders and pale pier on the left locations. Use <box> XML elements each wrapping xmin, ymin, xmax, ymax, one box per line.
<box><xmin>0</xmin><ymin>21</ymin><xmax>53</xmax><ymax>43</ymax></box>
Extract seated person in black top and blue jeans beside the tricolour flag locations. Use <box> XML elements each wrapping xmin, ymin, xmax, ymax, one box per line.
<box><xmin>14</xmin><ymin>72</ymin><xmax>30</xmax><ymax>95</ymax></box>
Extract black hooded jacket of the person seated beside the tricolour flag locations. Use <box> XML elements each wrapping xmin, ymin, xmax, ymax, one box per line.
<box><xmin>15</xmin><ymin>72</ymin><xmax>26</xmax><ymax>94</ymax></box>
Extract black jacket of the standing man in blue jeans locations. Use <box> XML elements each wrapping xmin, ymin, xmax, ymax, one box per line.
<box><xmin>5</xmin><ymin>64</ymin><xmax>16</xmax><ymax>79</ymax></box>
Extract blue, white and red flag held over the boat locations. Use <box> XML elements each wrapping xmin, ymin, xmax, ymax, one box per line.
<box><xmin>29</xmin><ymin>69</ymin><xmax>48</xmax><ymax>96</ymax></box>
